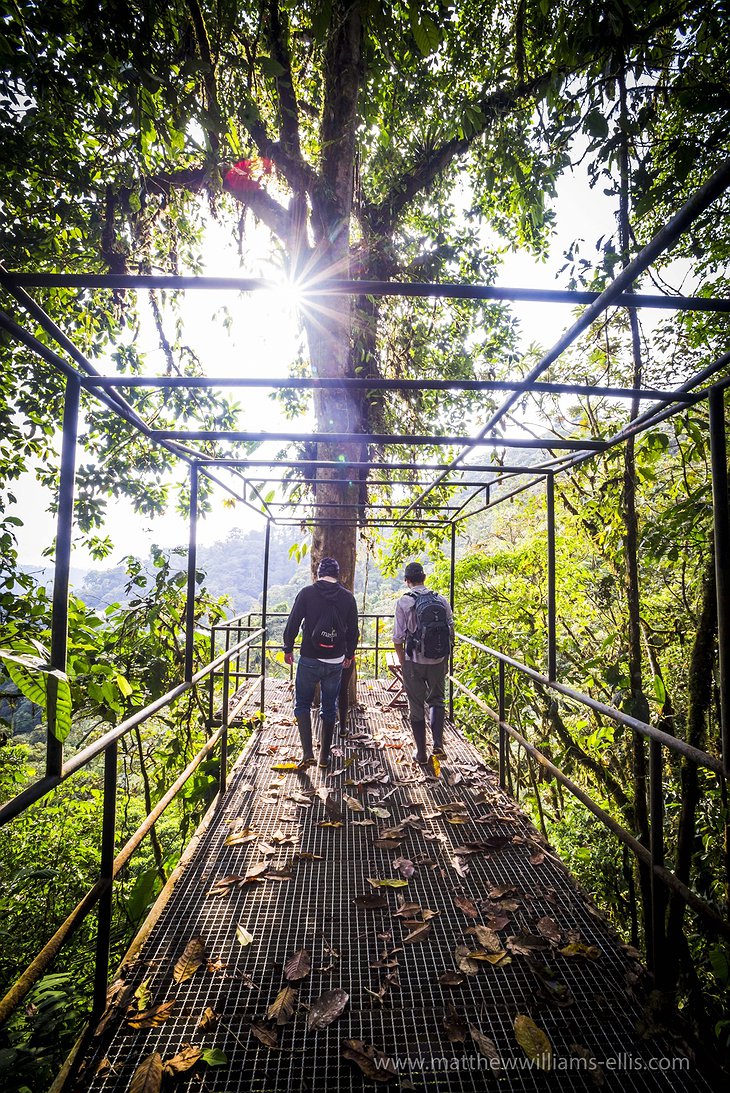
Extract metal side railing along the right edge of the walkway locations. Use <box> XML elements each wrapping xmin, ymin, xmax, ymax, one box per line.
<box><xmin>449</xmin><ymin>634</ymin><xmax>730</xmax><ymax>972</ymax></box>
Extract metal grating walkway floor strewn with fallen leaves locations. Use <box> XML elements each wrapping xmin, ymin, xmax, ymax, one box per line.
<box><xmin>74</xmin><ymin>682</ymin><xmax>709</xmax><ymax>1093</ymax></box>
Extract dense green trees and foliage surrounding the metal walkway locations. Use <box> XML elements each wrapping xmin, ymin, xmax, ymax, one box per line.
<box><xmin>0</xmin><ymin>0</ymin><xmax>730</xmax><ymax>1090</ymax></box>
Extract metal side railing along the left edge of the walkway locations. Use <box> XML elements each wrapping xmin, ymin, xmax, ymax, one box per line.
<box><xmin>0</xmin><ymin>628</ymin><xmax>264</xmax><ymax>1025</ymax></box>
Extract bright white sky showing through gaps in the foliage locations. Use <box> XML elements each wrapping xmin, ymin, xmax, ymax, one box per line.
<box><xmin>11</xmin><ymin>166</ymin><xmax>614</xmax><ymax>568</ymax></box>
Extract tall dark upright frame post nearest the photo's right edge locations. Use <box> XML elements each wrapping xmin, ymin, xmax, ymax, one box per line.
<box><xmin>709</xmin><ymin>387</ymin><xmax>730</xmax><ymax>777</ymax></box>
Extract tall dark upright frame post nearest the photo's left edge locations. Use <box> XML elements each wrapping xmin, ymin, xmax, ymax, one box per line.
<box><xmin>46</xmin><ymin>376</ymin><xmax>81</xmax><ymax>777</ymax></box>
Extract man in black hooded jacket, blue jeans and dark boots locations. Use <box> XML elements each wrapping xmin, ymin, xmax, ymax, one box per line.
<box><xmin>284</xmin><ymin>557</ymin><xmax>360</xmax><ymax>771</ymax></box>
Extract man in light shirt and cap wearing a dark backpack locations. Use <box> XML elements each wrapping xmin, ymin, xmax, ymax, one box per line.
<box><xmin>393</xmin><ymin>562</ymin><xmax>454</xmax><ymax>765</ymax></box>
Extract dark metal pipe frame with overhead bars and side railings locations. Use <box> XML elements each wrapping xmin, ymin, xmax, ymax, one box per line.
<box><xmin>0</xmin><ymin>161</ymin><xmax>730</xmax><ymax>1036</ymax></box>
